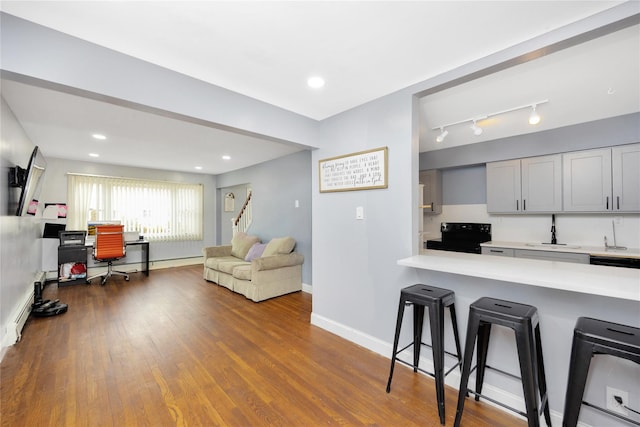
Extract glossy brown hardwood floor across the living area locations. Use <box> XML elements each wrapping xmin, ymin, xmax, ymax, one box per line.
<box><xmin>0</xmin><ymin>266</ymin><xmax>526</xmax><ymax>427</ymax></box>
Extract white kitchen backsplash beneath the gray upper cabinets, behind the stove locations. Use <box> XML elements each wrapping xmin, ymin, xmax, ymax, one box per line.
<box><xmin>423</xmin><ymin>204</ymin><xmax>640</xmax><ymax>248</ymax></box>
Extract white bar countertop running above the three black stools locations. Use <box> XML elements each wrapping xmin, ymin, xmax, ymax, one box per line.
<box><xmin>398</xmin><ymin>252</ymin><xmax>640</xmax><ymax>301</ymax></box>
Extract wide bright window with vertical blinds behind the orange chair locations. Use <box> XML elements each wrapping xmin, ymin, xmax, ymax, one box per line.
<box><xmin>67</xmin><ymin>174</ymin><xmax>203</xmax><ymax>241</ymax></box>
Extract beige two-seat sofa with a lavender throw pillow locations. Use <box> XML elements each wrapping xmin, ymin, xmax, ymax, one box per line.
<box><xmin>202</xmin><ymin>233</ymin><xmax>304</xmax><ymax>302</ymax></box>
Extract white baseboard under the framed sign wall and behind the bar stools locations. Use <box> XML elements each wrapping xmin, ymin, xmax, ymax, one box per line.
<box><xmin>311</xmin><ymin>313</ymin><xmax>568</xmax><ymax>427</ymax></box>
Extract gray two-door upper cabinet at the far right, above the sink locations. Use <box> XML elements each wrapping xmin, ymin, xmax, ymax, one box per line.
<box><xmin>562</xmin><ymin>144</ymin><xmax>640</xmax><ymax>212</ymax></box>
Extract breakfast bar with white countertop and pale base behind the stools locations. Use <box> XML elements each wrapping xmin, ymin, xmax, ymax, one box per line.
<box><xmin>397</xmin><ymin>250</ymin><xmax>640</xmax><ymax>426</ymax></box>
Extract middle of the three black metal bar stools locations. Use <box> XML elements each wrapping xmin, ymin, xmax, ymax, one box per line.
<box><xmin>454</xmin><ymin>297</ymin><xmax>551</xmax><ymax>427</ymax></box>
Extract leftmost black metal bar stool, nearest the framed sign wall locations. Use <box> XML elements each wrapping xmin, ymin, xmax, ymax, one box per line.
<box><xmin>387</xmin><ymin>284</ymin><xmax>462</xmax><ymax>425</ymax></box>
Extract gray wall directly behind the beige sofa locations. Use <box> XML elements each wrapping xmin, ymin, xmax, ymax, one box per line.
<box><xmin>217</xmin><ymin>150</ymin><xmax>313</xmax><ymax>285</ymax></box>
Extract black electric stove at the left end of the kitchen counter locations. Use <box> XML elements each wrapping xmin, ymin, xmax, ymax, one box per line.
<box><xmin>425</xmin><ymin>222</ymin><xmax>491</xmax><ymax>254</ymax></box>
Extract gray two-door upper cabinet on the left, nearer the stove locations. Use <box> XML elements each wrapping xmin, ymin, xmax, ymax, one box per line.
<box><xmin>487</xmin><ymin>155</ymin><xmax>562</xmax><ymax>213</ymax></box>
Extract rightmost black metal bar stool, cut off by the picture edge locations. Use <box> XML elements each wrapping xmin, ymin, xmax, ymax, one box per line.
<box><xmin>562</xmin><ymin>317</ymin><xmax>640</xmax><ymax>427</ymax></box>
